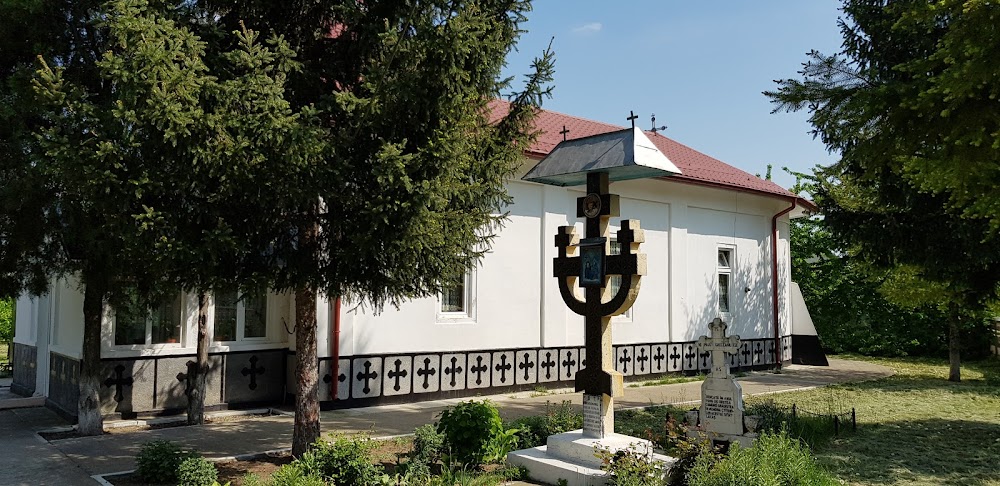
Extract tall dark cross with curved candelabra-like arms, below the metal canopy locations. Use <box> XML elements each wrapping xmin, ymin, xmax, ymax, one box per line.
<box><xmin>552</xmin><ymin>172</ymin><xmax>646</xmax><ymax>438</ymax></box>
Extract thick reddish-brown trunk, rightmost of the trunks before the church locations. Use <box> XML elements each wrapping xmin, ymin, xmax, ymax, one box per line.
<box><xmin>292</xmin><ymin>287</ymin><xmax>320</xmax><ymax>457</ymax></box>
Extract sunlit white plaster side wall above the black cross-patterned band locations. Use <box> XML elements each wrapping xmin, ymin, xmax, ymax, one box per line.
<box><xmin>338</xmin><ymin>172</ymin><xmax>787</xmax><ymax>356</ymax></box>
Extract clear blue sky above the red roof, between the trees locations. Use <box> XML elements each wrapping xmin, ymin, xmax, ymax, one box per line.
<box><xmin>507</xmin><ymin>0</ymin><xmax>841</xmax><ymax>192</ymax></box>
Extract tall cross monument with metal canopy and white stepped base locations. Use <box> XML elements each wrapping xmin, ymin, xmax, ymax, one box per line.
<box><xmin>508</xmin><ymin>115</ymin><xmax>680</xmax><ymax>486</ymax></box>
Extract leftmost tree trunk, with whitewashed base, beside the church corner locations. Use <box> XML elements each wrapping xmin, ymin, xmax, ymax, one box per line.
<box><xmin>77</xmin><ymin>278</ymin><xmax>104</xmax><ymax>435</ymax></box>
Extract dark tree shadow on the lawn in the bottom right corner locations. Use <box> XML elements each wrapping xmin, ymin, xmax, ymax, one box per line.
<box><xmin>816</xmin><ymin>419</ymin><xmax>1000</xmax><ymax>485</ymax></box>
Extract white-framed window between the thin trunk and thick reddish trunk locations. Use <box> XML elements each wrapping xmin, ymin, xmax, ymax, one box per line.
<box><xmin>214</xmin><ymin>290</ymin><xmax>267</xmax><ymax>342</ymax></box>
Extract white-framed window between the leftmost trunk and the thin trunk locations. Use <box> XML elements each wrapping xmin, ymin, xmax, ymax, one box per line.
<box><xmin>114</xmin><ymin>292</ymin><xmax>181</xmax><ymax>346</ymax></box>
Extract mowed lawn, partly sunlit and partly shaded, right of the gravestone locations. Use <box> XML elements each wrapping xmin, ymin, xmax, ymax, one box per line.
<box><xmin>748</xmin><ymin>358</ymin><xmax>1000</xmax><ymax>486</ymax></box>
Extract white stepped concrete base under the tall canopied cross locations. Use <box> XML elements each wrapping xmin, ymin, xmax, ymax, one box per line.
<box><xmin>507</xmin><ymin>430</ymin><xmax>677</xmax><ymax>486</ymax></box>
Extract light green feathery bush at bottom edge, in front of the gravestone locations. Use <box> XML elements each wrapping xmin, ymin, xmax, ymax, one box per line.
<box><xmin>687</xmin><ymin>431</ymin><xmax>839</xmax><ymax>486</ymax></box>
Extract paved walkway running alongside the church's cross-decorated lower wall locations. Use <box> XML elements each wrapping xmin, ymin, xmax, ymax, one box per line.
<box><xmin>0</xmin><ymin>359</ymin><xmax>892</xmax><ymax>485</ymax></box>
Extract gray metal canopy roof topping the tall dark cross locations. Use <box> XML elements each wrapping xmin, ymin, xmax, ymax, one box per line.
<box><xmin>522</xmin><ymin>128</ymin><xmax>681</xmax><ymax>186</ymax></box>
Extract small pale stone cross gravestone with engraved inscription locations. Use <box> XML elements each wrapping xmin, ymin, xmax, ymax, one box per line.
<box><xmin>688</xmin><ymin>317</ymin><xmax>757</xmax><ymax>447</ymax></box>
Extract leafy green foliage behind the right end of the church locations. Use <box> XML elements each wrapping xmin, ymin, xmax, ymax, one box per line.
<box><xmin>791</xmin><ymin>174</ymin><xmax>986</xmax><ymax>356</ymax></box>
